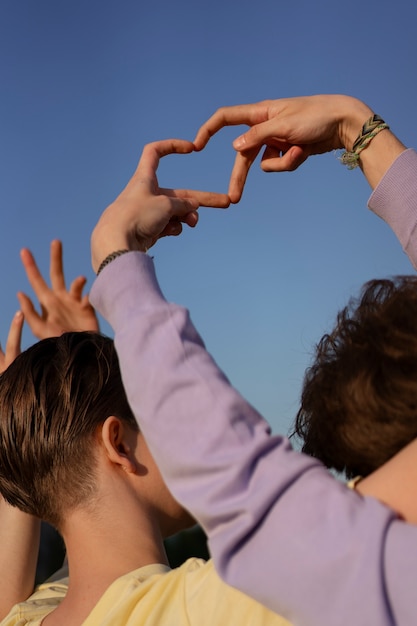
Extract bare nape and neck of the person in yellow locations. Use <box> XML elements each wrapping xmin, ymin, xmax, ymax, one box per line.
<box><xmin>43</xmin><ymin>488</ymin><xmax>168</xmax><ymax>626</ymax></box>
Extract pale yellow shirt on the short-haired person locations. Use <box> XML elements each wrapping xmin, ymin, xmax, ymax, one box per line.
<box><xmin>0</xmin><ymin>558</ymin><xmax>289</xmax><ymax>626</ymax></box>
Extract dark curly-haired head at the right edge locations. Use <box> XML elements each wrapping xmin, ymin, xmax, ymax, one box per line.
<box><xmin>293</xmin><ymin>276</ymin><xmax>417</xmax><ymax>478</ymax></box>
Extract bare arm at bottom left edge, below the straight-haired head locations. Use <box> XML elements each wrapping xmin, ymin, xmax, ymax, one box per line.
<box><xmin>0</xmin><ymin>498</ymin><xmax>40</xmax><ymax>618</ymax></box>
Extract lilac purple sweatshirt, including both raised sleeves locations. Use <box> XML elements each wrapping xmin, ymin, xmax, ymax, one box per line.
<box><xmin>90</xmin><ymin>150</ymin><xmax>417</xmax><ymax>626</ymax></box>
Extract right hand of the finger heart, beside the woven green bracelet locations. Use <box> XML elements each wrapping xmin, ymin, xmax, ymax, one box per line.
<box><xmin>194</xmin><ymin>95</ymin><xmax>390</xmax><ymax>202</ymax></box>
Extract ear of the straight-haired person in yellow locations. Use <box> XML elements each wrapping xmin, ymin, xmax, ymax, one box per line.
<box><xmin>100</xmin><ymin>415</ymin><xmax>137</xmax><ymax>474</ymax></box>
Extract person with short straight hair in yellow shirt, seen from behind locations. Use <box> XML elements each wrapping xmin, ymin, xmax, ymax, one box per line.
<box><xmin>0</xmin><ymin>332</ymin><xmax>287</xmax><ymax>626</ymax></box>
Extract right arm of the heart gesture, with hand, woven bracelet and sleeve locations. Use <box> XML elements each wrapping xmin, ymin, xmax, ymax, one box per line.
<box><xmin>194</xmin><ymin>95</ymin><xmax>417</xmax><ymax>268</ymax></box>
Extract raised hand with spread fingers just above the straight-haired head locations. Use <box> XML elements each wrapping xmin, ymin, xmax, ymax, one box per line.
<box><xmin>17</xmin><ymin>240</ymin><xmax>99</xmax><ymax>339</ymax></box>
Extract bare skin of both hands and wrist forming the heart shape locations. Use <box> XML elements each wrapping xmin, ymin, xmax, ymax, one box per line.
<box><xmin>91</xmin><ymin>95</ymin><xmax>406</xmax><ymax>272</ymax></box>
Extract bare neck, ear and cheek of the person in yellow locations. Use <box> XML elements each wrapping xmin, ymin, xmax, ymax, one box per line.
<box><xmin>43</xmin><ymin>416</ymin><xmax>194</xmax><ymax>626</ymax></box>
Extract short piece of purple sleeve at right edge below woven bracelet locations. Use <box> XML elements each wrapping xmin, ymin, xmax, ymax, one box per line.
<box><xmin>368</xmin><ymin>148</ymin><xmax>417</xmax><ymax>269</ymax></box>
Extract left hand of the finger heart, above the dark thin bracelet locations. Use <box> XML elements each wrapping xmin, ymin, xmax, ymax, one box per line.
<box><xmin>91</xmin><ymin>139</ymin><xmax>230</xmax><ymax>271</ymax></box>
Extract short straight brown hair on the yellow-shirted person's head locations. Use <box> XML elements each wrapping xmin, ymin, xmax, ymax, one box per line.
<box><xmin>0</xmin><ymin>332</ymin><xmax>137</xmax><ymax>528</ymax></box>
